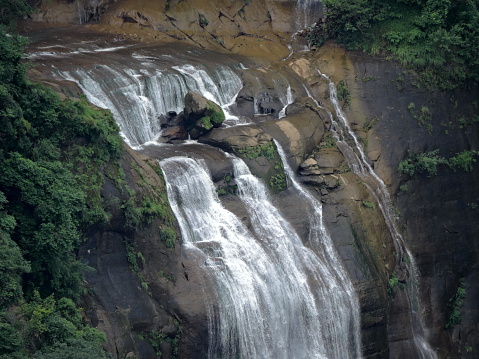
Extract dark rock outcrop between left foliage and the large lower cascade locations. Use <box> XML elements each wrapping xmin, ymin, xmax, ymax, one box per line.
<box><xmin>80</xmin><ymin>143</ymin><xmax>209</xmax><ymax>359</ymax></box>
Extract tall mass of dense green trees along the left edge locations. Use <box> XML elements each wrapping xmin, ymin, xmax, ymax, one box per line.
<box><xmin>0</xmin><ymin>4</ymin><xmax>120</xmax><ymax>359</ymax></box>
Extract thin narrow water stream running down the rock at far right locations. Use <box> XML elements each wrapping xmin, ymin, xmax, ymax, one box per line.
<box><xmin>316</xmin><ymin>70</ymin><xmax>437</xmax><ymax>359</ymax></box>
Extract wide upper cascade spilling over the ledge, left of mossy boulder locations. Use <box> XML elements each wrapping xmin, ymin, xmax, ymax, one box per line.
<box><xmin>58</xmin><ymin>65</ymin><xmax>242</xmax><ymax>147</ymax></box>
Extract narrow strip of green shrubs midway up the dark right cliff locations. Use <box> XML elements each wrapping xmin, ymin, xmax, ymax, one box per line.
<box><xmin>398</xmin><ymin>150</ymin><xmax>479</xmax><ymax>177</ymax></box>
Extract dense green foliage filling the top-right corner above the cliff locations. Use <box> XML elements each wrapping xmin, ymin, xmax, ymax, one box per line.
<box><xmin>309</xmin><ymin>0</ymin><xmax>479</xmax><ymax>88</ymax></box>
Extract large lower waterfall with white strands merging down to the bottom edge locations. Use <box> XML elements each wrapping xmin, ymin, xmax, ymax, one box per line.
<box><xmin>160</xmin><ymin>153</ymin><xmax>361</xmax><ymax>359</ymax></box>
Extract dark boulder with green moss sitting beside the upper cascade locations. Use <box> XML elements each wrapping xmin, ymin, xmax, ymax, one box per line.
<box><xmin>183</xmin><ymin>91</ymin><xmax>225</xmax><ymax>140</ymax></box>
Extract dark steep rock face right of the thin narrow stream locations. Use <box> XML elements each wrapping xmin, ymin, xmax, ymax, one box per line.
<box><xmin>317</xmin><ymin>42</ymin><xmax>479</xmax><ymax>358</ymax></box>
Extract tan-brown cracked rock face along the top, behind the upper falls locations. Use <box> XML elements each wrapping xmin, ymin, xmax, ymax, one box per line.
<box><xmin>28</xmin><ymin>0</ymin><xmax>318</xmax><ymax>58</ymax></box>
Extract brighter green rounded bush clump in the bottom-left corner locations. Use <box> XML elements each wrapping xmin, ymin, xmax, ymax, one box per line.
<box><xmin>0</xmin><ymin>291</ymin><xmax>107</xmax><ymax>359</ymax></box>
